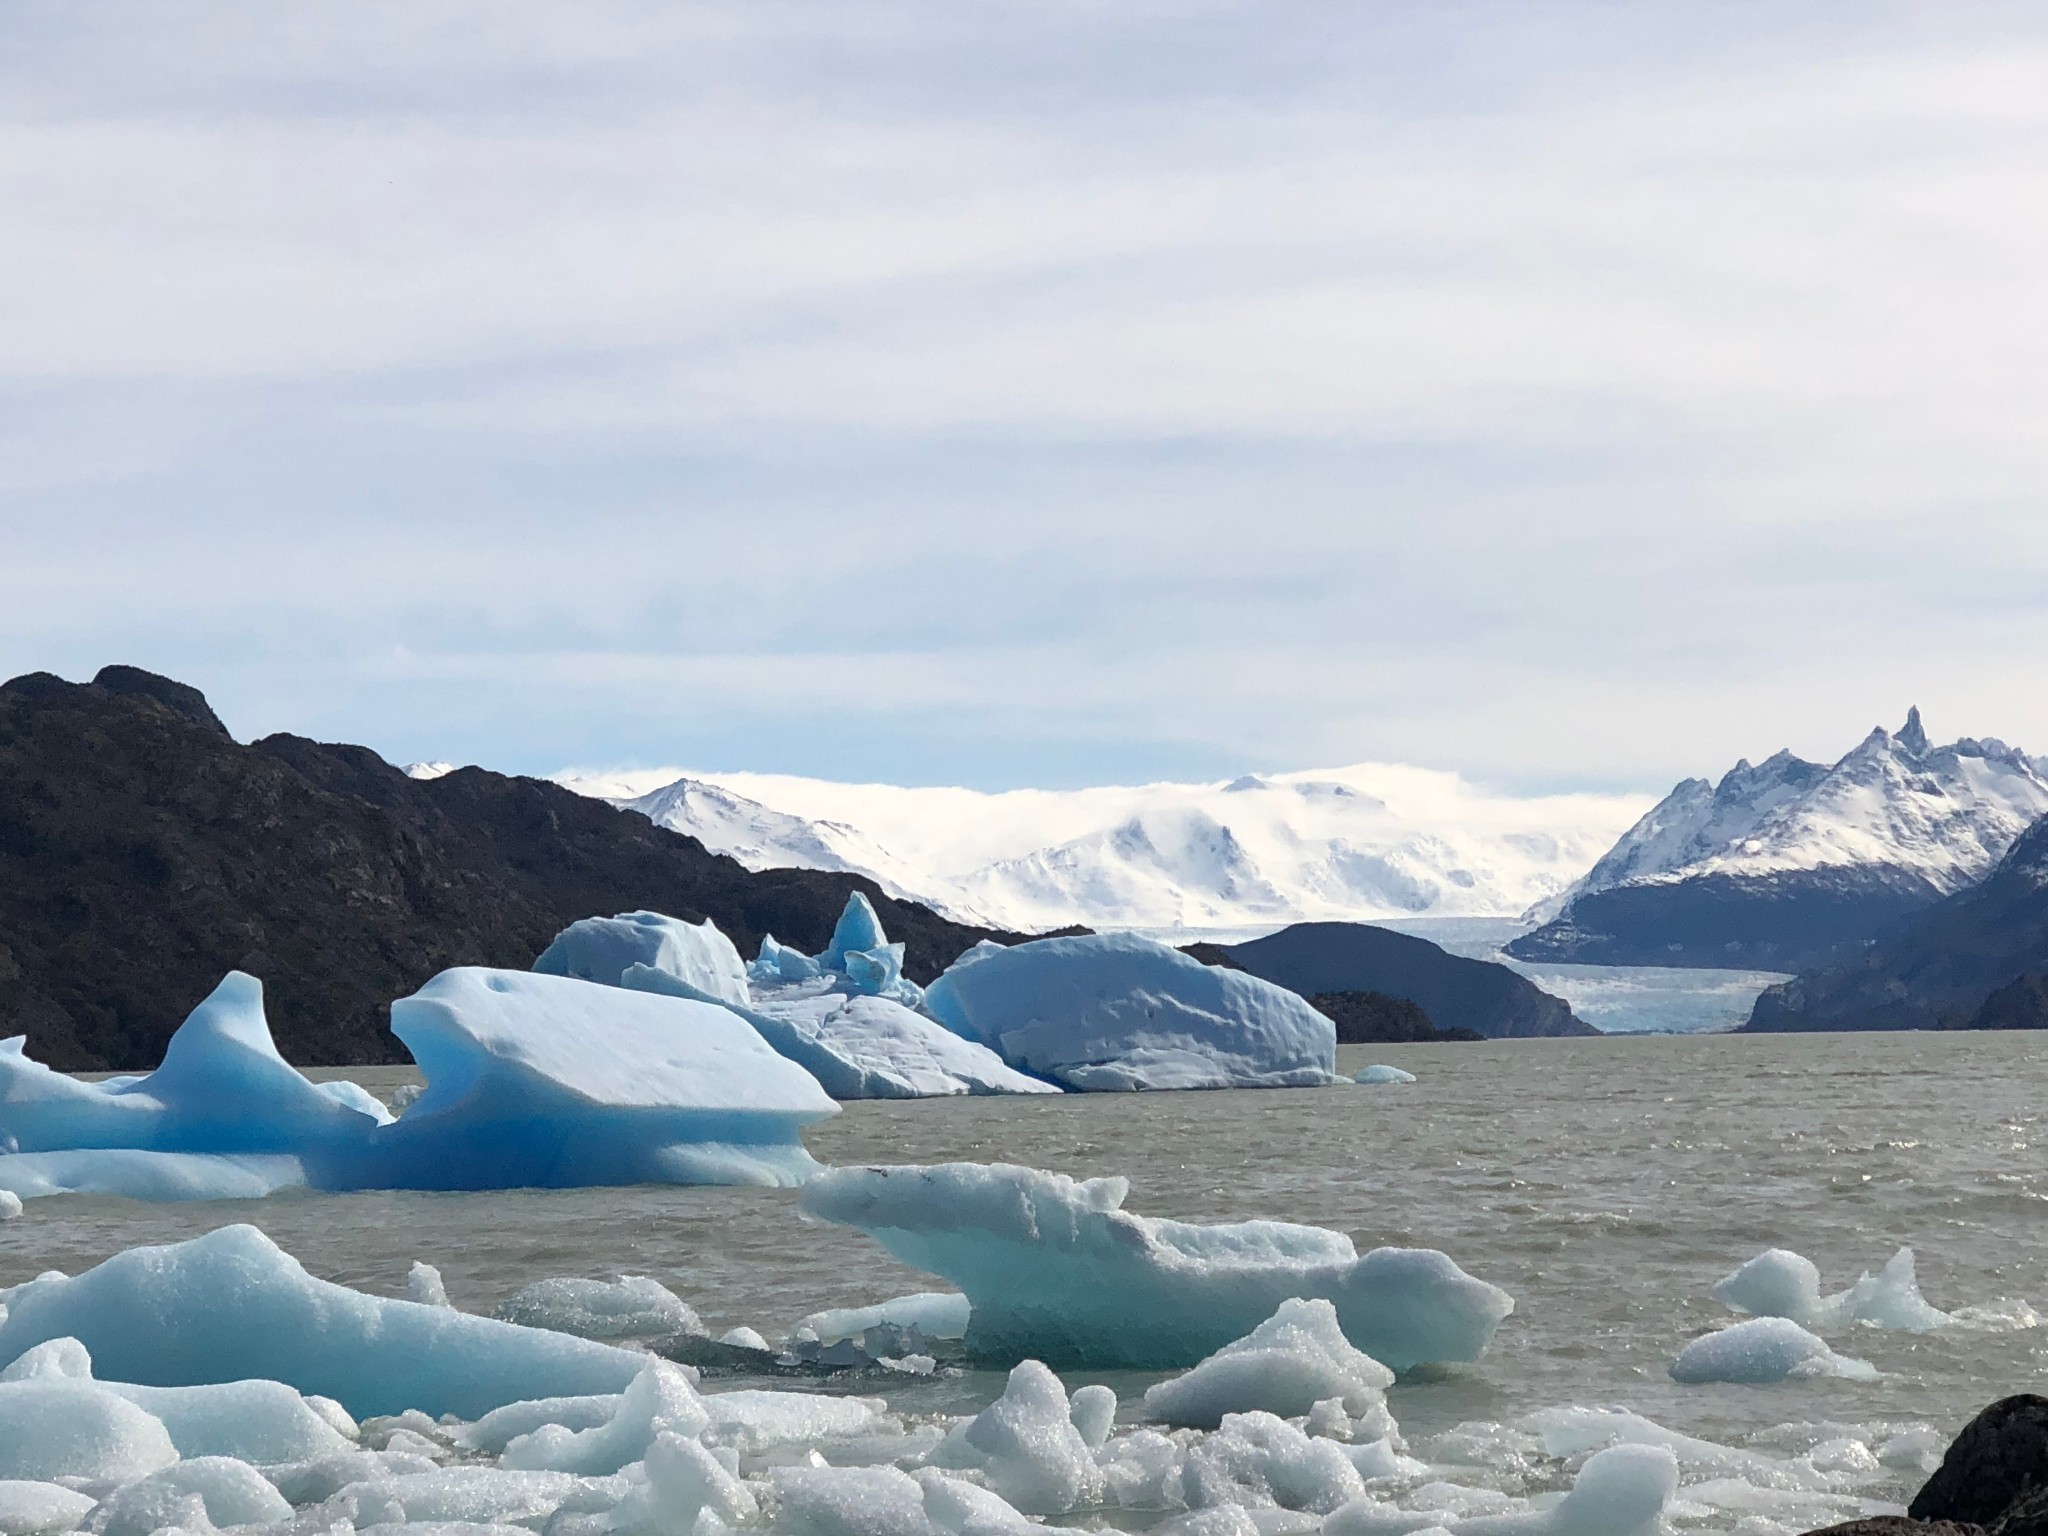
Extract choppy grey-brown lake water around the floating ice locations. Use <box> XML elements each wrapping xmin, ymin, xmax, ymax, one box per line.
<box><xmin>0</xmin><ymin>1034</ymin><xmax>2048</xmax><ymax>1507</ymax></box>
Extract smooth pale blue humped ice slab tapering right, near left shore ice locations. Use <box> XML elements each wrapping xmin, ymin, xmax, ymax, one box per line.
<box><xmin>0</xmin><ymin>1228</ymin><xmax>645</xmax><ymax>1430</ymax></box>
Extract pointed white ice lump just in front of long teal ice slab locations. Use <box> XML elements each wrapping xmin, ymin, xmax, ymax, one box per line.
<box><xmin>1145</xmin><ymin>1296</ymin><xmax>1395</xmax><ymax>1438</ymax></box>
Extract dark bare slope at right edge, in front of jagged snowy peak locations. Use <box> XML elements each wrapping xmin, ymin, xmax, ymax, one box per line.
<box><xmin>1743</xmin><ymin>819</ymin><xmax>2048</xmax><ymax>1032</ymax></box>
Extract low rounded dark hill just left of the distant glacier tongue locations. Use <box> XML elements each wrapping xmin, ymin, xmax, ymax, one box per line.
<box><xmin>1219</xmin><ymin>924</ymin><xmax>1599</xmax><ymax>1040</ymax></box>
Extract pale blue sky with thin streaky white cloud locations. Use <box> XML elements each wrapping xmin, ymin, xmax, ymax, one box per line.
<box><xmin>0</xmin><ymin>0</ymin><xmax>2048</xmax><ymax>793</ymax></box>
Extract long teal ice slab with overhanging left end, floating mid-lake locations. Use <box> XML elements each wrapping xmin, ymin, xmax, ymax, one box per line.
<box><xmin>801</xmin><ymin>1163</ymin><xmax>1513</xmax><ymax>1370</ymax></box>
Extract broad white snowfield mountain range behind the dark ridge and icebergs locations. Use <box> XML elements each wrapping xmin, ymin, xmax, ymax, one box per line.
<box><xmin>561</xmin><ymin>764</ymin><xmax>1642</xmax><ymax>932</ymax></box>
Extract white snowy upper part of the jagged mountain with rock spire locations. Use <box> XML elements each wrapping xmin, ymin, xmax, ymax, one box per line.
<box><xmin>1538</xmin><ymin>709</ymin><xmax>2048</xmax><ymax>915</ymax></box>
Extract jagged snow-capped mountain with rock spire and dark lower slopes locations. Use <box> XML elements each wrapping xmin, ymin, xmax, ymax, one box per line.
<box><xmin>1509</xmin><ymin>709</ymin><xmax>2048</xmax><ymax>969</ymax></box>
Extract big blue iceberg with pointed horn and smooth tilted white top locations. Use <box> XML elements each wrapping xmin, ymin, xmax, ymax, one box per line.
<box><xmin>0</xmin><ymin>967</ymin><xmax>838</xmax><ymax>1200</ymax></box>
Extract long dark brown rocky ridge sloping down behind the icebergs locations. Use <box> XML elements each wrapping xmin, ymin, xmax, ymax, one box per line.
<box><xmin>0</xmin><ymin>668</ymin><xmax>1020</xmax><ymax>1071</ymax></box>
